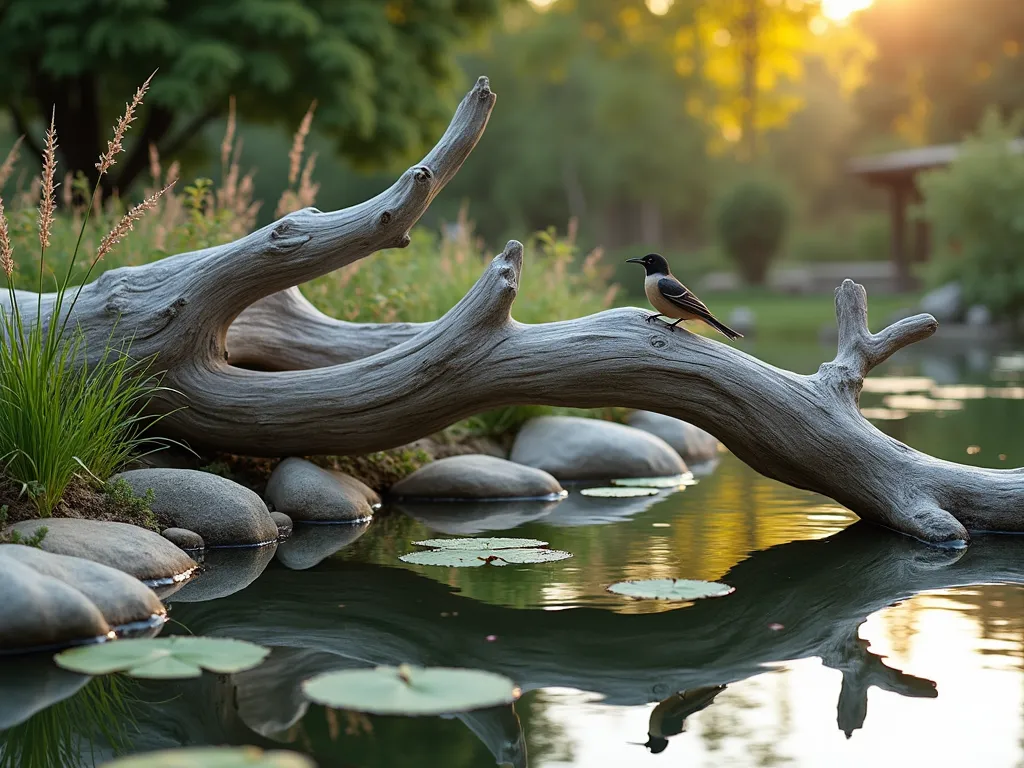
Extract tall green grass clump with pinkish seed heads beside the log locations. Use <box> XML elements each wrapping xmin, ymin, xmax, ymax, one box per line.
<box><xmin>0</xmin><ymin>77</ymin><xmax>170</xmax><ymax>517</ymax></box>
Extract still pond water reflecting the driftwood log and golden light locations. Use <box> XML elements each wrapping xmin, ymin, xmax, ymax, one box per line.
<box><xmin>0</xmin><ymin>341</ymin><xmax>1024</xmax><ymax>768</ymax></box>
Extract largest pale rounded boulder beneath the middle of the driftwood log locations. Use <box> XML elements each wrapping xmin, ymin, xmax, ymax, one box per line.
<box><xmin>511</xmin><ymin>416</ymin><xmax>687</xmax><ymax>480</ymax></box>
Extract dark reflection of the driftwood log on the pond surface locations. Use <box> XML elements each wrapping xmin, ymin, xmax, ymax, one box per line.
<box><xmin>157</xmin><ymin>524</ymin><xmax>1024</xmax><ymax>745</ymax></box>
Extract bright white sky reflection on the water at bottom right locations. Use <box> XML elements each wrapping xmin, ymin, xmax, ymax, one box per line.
<box><xmin>531</xmin><ymin>586</ymin><xmax>1024</xmax><ymax>768</ymax></box>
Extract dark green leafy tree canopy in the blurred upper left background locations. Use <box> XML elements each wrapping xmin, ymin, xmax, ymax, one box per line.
<box><xmin>0</xmin><ymin>0</ymin><xmax>501</xmax><ymax>189</ymax></box>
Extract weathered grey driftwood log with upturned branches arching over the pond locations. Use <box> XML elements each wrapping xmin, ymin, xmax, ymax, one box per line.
<box><xmin>2</xmin><ymin>78</ymin><xmax>1024</xmax><ymax>543</ymax></box>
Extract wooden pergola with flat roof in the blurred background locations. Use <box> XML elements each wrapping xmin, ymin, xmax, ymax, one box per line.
<box><xmin>849</xmin><ymin>139</ymin><xmax>1024</xmax><ymax>291</ymax></box>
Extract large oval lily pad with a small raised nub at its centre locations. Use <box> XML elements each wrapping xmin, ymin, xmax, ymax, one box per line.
<box><xmin>302</xmin><ymin>665</ymin><xmax>519</xmax><ymax>715</ymax></box>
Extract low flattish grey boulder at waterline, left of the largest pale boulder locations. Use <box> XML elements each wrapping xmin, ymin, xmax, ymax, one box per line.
<box><xmin>389</xmin><ymin>454</ymin><xmax>562</xmax><ymax>501</ymax></box>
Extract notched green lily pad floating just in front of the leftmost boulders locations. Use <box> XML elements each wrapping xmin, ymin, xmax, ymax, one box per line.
<box><xmin>53</xmin><ymin>637</ymin><xmax>270</xmax><ymax>680</ymax></box>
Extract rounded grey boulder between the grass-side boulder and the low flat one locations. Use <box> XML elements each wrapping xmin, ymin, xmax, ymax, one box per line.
<box><xmin>264</xmin><ymin>457</ymin><xmax>380</xmax><ymax>522</ymax></box>
